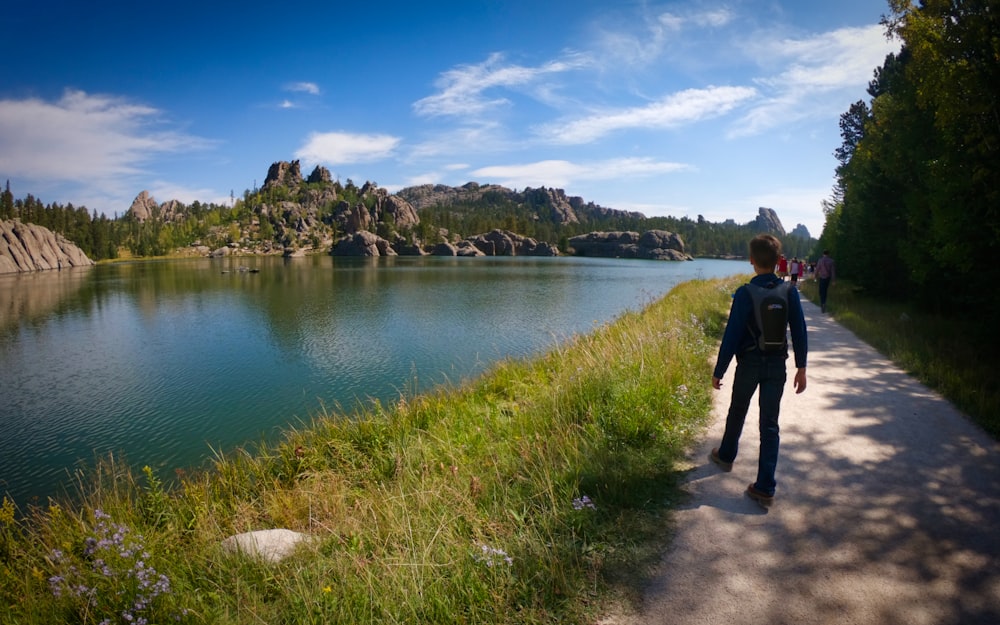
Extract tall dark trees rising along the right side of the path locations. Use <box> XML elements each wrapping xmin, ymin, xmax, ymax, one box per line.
<box><xmin>820</xmin><ymin>0</ymin><xmax>1000</xmax><ymax>326</ymax></box>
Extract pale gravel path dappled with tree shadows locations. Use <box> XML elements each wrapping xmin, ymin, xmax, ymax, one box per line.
<box><xmin>604</xmin><ymin>301</ymin><xmax>1000</xmax><ymax>625</ymax></box>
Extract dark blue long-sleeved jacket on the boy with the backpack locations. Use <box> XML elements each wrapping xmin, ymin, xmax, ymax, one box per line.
<box><xmin>712</xmin><ymin>273</ymin><xmax>809</xmax><ymax>379</ymax></box>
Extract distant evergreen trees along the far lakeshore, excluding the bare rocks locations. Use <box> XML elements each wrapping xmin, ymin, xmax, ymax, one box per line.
<box><xmin>0</xmin><ymin>180</ymin><xmax>816</xmax><ymax>260</ymax></box>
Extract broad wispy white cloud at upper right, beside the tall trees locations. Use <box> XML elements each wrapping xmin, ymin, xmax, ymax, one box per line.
<box><xmin>730</xmin><ymin>25</ymin><xmax>899</xmax><ymax>136</ymax></box>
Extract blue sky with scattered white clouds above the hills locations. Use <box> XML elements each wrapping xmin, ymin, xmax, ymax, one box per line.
<box><xmin>0</xmin><ymin>0</ymin><xmax>899</xmax><ymax>236</ymax></box>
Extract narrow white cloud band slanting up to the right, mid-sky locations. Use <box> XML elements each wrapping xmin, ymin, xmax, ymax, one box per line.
<box><xmin>539</xmin><ymin>87</ymin><xmax>757</xmax><ymax>144</ymax></box>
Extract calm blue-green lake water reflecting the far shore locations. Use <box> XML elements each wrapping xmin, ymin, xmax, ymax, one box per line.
<box><xmin>0</xmin><ymin>256</ymin><xmax>749</xmax><ymax>503</ymax></box>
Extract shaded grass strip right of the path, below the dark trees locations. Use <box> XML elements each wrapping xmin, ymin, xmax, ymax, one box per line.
<box><xmin>801</xmin><ymin>280</ymin><xmax>1000</xmax><ymax>439</ymax></box>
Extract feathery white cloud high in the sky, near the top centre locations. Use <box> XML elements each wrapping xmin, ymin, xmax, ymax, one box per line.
<box><xmin>413</xmin><ymin>53</ymin><xmax>589</xmax><ymax>117</ymax></box>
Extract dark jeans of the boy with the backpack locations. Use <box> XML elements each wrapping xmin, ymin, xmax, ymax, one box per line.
<box><xmin>719</xmin><ymin>350</ymin><xmax>788</xmax><ymax>495</ymax></box>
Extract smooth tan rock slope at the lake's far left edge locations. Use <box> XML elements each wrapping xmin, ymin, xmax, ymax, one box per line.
<box><xmin>0</xmin><ymin>219</ymin><xmax>94</xmax><ymax>273</ymax></box>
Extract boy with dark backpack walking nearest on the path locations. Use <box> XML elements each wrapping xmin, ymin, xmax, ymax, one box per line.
<box><xmin>709</xmin><ymin>234</ymin><xmax>808</xmax><ymax>506</ymax></box>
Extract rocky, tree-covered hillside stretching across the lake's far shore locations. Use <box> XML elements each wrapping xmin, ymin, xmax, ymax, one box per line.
<box><xmin>0</xmin><ymin>161</ymin><xmax>815</xmax><ymax>260</ymax></box>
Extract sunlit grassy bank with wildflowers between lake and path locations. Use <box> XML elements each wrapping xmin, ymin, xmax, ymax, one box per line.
<box><xmin>0</xmin><ymin>278</ymin><xmax>743</xmax><ymax>624</ymax></box>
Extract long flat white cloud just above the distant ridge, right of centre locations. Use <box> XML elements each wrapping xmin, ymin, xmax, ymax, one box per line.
<box><xmin>470</xmin><ymin>158</ymin><xmax>690</xmax><ymax>188</ymax></box>
